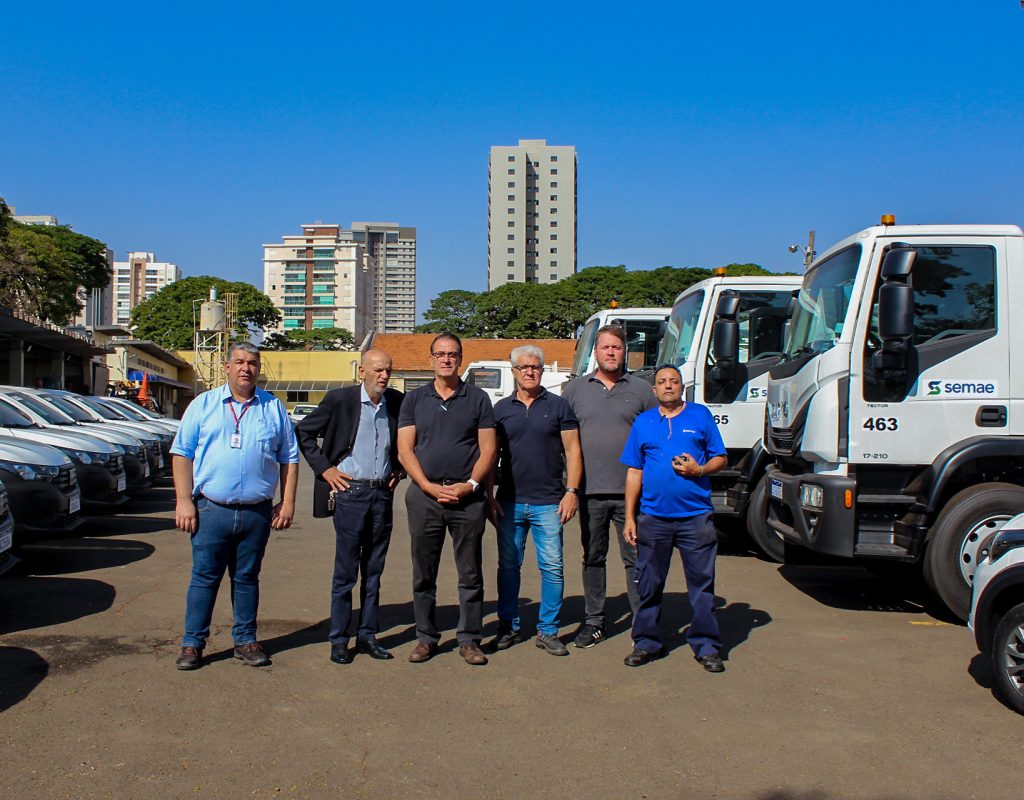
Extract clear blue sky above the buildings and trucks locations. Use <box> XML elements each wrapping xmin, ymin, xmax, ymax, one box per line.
<box><xmin>0</xmin><ymin>0</ymin><xmax>1024</xmax><ymax>321</ymax></box>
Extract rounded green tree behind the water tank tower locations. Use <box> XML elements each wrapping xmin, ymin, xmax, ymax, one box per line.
<box><xmin>131</xmin><ymin>276</ymin><xmax>281</xmax><ymax>350</ymax></box>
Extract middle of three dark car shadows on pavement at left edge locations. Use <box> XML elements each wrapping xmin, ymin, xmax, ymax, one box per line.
<box><xmin>0</xmin><ymin>576</ymin><xmax>117</xmax><ymax>635</ymax></box>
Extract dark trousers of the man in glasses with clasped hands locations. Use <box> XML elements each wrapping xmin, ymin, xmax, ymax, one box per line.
<box><xmin>406</xmin><ymin>483</ymin><xmax>485</xmax><ymax>644</ymax></box>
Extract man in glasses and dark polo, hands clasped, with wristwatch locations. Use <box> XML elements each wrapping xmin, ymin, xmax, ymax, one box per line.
<box><xmin>398</xmin><ymin>333</ymin><xmax>497</xmax><ymax>665</ymax></box>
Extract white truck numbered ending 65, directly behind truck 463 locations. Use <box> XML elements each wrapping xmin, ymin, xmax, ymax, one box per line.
<box><xmin>641</xmin><ymin>276</ymin><xmax>802</xmax><ymax>560</ymax></box>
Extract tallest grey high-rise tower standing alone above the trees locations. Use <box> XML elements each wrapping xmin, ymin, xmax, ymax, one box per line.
<box><xmin>487</xmin><ymin>139</ymin><xmax>577</xmax><ymax>289</ymax></box>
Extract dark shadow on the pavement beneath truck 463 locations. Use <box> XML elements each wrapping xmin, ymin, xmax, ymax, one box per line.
<box><xmin>778</xmin><ymin>564</ymin><xmax>963</xmax><ymax>625</ymax></box>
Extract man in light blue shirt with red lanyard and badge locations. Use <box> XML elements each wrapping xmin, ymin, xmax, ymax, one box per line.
<box><xmin>171</xmin><ymin>342</ymin><xmax>299</xmax><ymax>670</ymax></box>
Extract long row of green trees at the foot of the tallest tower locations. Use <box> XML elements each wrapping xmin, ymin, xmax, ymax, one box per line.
<box><xmin>417</xmin><ymin>264</ymin><xmax>773</xmax><ymax>339</ymax></box>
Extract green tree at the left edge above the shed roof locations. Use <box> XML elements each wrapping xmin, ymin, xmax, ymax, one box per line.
<box><xmin>0</xmin><ymin>198</ymin><xmax>113</xmax><ymax>325</ymax></box>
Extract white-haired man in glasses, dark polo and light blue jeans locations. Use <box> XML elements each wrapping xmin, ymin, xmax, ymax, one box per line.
<box><xmin>492</xmin><ymin>344</ymin><xmax>583</xmax><ymax>656</ymax></box>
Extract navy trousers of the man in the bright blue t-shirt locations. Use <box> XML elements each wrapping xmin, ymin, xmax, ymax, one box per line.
<box><xmin>633</xmin><ymin>512</ymin><xmax>722</xmax><ymax>658</ymax></box>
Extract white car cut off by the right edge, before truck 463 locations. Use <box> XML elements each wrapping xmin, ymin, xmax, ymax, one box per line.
<box><xmin>967</xmin><ymin>514</ymin><xmax>1024</xmax><ymax>714</ymax></box>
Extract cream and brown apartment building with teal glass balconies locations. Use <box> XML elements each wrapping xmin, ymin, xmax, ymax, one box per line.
<box><xmin>263</xmin><ymin>222</ymin><xmax>377</xmax><ymax>343</ymax></box>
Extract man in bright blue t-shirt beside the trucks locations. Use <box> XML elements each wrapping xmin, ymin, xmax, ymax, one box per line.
<box><xmin>622</xmin><ymin>365</ymin><xmax>727</xmax><ymax>672</ymax></box>
